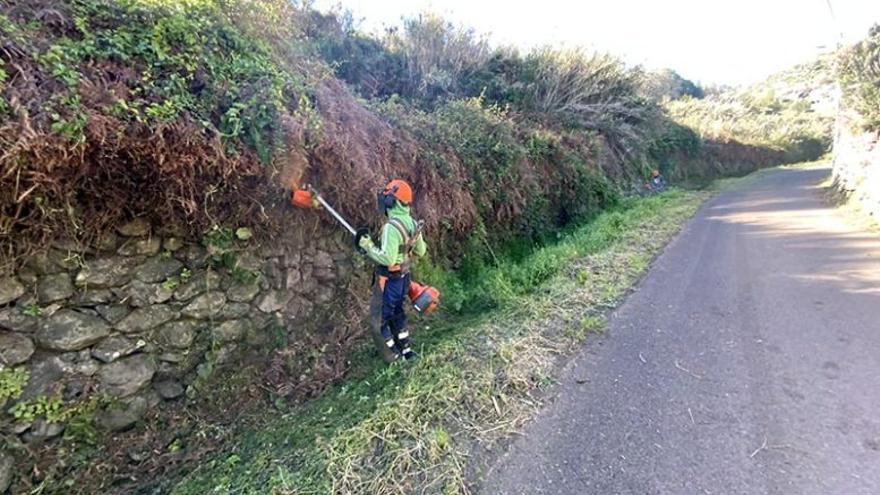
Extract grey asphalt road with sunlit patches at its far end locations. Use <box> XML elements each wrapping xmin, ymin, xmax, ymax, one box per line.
<box><xmin>482</xmin><ymin>169</ymin><xmax>880</xmax><ymax>495</ymax></box>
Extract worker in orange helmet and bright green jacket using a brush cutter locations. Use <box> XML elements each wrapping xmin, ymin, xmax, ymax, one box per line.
<box><xmin>357</xmin><ymin>179</ymin><xmax>427</xmax><ymax>360</ymax></box>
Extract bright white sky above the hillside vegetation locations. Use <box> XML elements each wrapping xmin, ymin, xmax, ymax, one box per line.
<box><xmin>314</xmin><ymin>0</ymin><xmax>880</xmax><ymax>84</ymax></box>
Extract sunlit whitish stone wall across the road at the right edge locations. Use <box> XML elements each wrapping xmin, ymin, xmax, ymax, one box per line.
<box><xmin>833</xmin><ymin>118</ymin><xmax>880</xmax><ymax>222</ymax></box>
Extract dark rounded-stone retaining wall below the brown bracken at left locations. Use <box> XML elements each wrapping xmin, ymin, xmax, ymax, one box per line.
<box><xmin>0</xmin><ymin>220</ymin><xmax>354</xmax><ymax>442</ymax></box>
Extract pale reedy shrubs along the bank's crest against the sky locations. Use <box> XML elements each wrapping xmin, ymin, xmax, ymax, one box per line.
<box><xmin>309</xmin><ymin>14</ymin><xmax>660</xmax><ymax>169</ymax></box>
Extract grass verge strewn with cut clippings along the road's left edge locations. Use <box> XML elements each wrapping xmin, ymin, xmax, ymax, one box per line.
<box><xmin>160</xmin><ymin>190</ymin><xmax>708</xmax><ymax>495</ymax></box>
